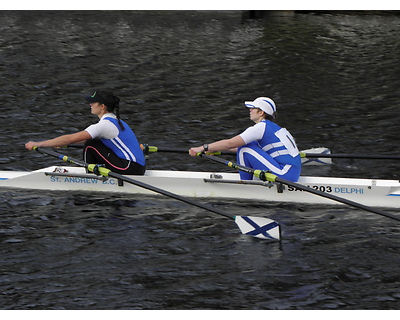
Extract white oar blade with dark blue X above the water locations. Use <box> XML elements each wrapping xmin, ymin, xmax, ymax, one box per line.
<box><xmin>235</xmin><ymin>216</ymin><xmax>281</xmax><ymax>240</ymax></box>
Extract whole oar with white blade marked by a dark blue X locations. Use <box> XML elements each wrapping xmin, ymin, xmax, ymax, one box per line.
<box><xmin>34</xmin><ymin>147</ymin><xmax>280</xmax><ymax>240</ymax></box>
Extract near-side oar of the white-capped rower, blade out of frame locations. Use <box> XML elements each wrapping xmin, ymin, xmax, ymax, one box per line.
<box><xmin>200</xmin><ymin>154</ymin><xmax>400</xmax><ymax>221</ymax></box>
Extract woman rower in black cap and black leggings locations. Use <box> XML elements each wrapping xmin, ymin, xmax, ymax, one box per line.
<box><xmin>25</xmin><ymin>90</ymin><xmax>146</xmax><ymax>175</ymax></box>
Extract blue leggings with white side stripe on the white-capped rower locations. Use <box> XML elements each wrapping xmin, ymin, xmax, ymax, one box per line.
<box><xmin>237</xmin><ymin>142</ymin><xmax>301</xmax><ymax>182</ymax></box>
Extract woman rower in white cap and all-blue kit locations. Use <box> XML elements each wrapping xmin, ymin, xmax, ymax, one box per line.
<box><xmin>189</xmin><ymin>97</ymin><xmax>301</xmax><ymax>182</ymax></box>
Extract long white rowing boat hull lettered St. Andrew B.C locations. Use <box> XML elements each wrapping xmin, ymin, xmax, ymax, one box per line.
<box><xmin>0</xmin><ymin>167</ymin><xmax>400</xmax><ymax>208</ymax></box>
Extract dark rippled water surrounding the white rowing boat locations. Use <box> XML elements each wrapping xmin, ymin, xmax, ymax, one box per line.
<box><xmin>0</xmin><ymin>11</ymin><xmax>400</xmax><ymax>309</ymax></box>
